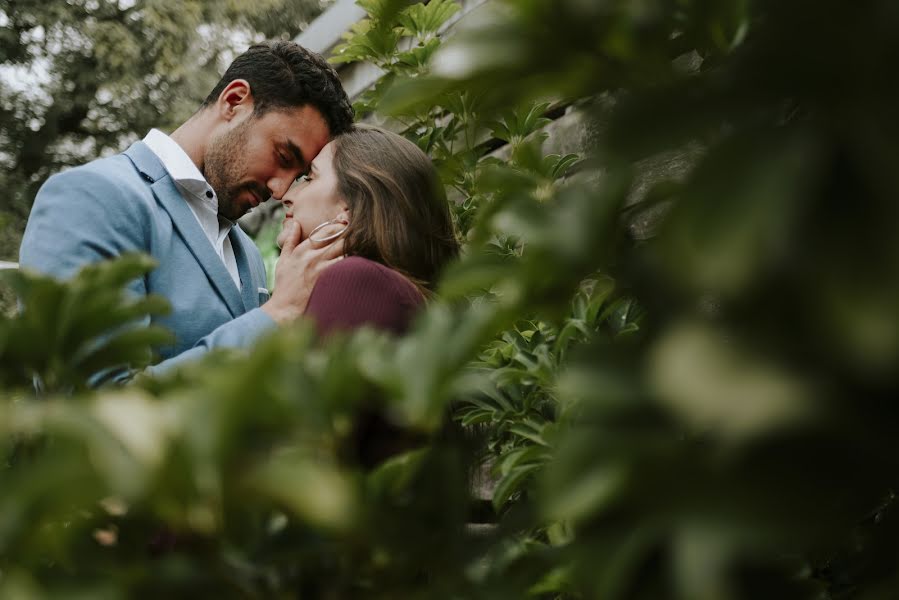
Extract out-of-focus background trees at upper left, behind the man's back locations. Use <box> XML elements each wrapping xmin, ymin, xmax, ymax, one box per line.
<box><xmin>0</xmin><ymin>0</ymin><xmax>323</xmax><ymax>261</ymax></box>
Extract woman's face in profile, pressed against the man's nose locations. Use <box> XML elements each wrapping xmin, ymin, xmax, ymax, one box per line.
<box><xmin>278</xmin><ymin>142</ymin><xmax>349</xmax><ymax>247</ymax></box>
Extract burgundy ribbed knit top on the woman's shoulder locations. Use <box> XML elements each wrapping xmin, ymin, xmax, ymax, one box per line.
<box><xmin>306</xmin><ymin>256</ymin><xmax>424</xmax><ymax>336</ymax></box>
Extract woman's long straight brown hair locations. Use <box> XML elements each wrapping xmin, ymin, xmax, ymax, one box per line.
<box><xmin>334</xmin><ymin>125</ymin><xmax>459</xmax><ymax>295</ymax></box>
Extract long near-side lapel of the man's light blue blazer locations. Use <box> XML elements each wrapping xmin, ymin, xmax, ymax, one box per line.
<box><xmin>125</xmin><ymin>142</ymin><xmax>247</xmax><ymax>317</ymax></box>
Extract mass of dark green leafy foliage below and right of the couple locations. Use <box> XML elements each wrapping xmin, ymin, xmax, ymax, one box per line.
<box><xmin>0</xmin><ymin>0</ymin><xmax>899</xmax><ymax>600</ymax></box>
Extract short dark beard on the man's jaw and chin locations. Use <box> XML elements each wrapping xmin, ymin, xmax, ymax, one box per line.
<box><xmin>203</xmin><ymin>119</ymin><xmax>269</xmax><ymax>221</ymax></box>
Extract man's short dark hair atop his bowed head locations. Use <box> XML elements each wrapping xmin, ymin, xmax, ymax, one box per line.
<box><xmin>203</xmin><ymin>41</ymin><xmax>353</xmax><ymax>136</ymax></box>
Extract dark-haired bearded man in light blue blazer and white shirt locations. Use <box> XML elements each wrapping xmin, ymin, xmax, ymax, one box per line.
<box><xmin>19</xmin><ymin>42</ymin><xmax>353</xmax><ymax>372</ymax></box>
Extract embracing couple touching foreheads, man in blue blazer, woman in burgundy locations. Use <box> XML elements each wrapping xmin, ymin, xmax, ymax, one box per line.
<box><xmin>20</xmin><ymin>42</ymin><xmax>458</xmax><ymax>372</ymax></box>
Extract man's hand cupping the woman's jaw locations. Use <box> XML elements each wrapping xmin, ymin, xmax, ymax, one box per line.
<box><xmin>262</xmin><ymin>223</ymin><xmax>343</xmax><ymax>324</ymax></box>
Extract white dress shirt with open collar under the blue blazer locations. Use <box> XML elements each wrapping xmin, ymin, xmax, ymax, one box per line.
<box><xmin>144</xmin><ymin>129</ymin><xmax>240</xmax><ymax>290</ymax></box>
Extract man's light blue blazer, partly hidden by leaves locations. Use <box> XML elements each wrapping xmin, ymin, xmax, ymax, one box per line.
<box><xmin>19</xmin><ymin>142</ymin><xmax>275</xmax><ymax>372</ymax></box>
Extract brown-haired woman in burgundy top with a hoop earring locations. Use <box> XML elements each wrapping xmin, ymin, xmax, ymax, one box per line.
<box><xmin>278</xmin><ymin>125</ymin><xmax>459</xmax><ymax>335</ymax></box>
